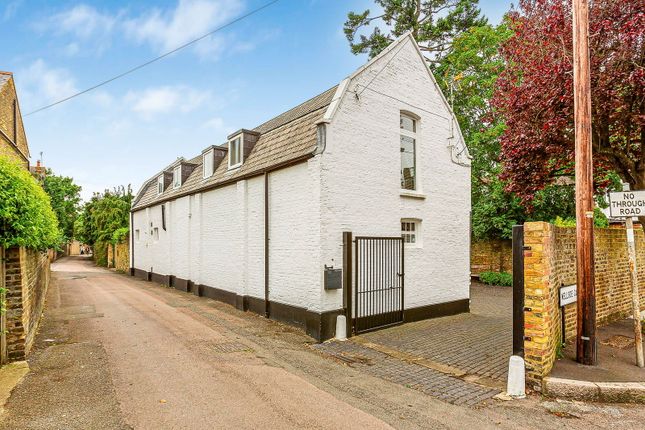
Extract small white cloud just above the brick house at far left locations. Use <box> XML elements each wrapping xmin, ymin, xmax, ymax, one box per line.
<box><xmin>17</xmin><ymin>59</ymin><xmax>78</xmax><ymax>109</ymax></box>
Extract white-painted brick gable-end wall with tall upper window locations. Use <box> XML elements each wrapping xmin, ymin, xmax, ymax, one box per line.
<box><xmin>321</xmin><ymin>37</ymin><xmax>470</xmax><ymax>310</ymax></box>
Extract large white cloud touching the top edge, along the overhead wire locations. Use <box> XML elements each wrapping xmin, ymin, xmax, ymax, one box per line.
<box><xmin>125</xmin><ymin>0</ymin><xmax>243</xmax><ymax>58</ymax></box>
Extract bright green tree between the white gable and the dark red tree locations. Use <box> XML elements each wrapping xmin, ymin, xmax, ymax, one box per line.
<box><xmin>435</xmin><ymin>23</ymin><xmax>575</xmax><ymax>240</ymax></box>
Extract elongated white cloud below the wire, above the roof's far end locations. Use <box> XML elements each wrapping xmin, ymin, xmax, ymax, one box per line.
<box><xmin>124</xmin><ymin>85</ymin><xmax>211</xmax><ymax>119</ymax></box>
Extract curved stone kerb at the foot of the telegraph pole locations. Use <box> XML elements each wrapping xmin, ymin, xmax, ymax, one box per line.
<box><xmin>542</xmin><ymin>376</ymin><xmax>645</xmax><ymax>404</ymax></box>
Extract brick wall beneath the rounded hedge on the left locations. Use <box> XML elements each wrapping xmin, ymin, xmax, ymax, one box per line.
<box><xmin>5</xmin><ymin>248</ymin><xmax>51</xmax><ymax>360</ymax></box>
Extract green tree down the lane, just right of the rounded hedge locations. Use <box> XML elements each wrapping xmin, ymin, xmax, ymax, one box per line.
<box><xmin>42</xmin><ymin>169</ymin><xmax>81</xmax><ymax>241</ymax></box>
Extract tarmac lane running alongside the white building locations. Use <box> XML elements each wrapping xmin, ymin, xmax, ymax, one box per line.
<box><xmin>0</xmin><ymin>258</ymin><xmax>645</xmax><ymax>430</ymax></box>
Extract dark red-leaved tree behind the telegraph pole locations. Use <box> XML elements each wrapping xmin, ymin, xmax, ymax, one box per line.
<box><xmin>491</xmin><ymin>0</ymin><xmax>645</xmax><ymax>202</ymax></box>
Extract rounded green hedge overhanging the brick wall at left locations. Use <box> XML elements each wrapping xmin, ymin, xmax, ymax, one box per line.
<box><xmin>0</xmin><ymin>157</ymin><xmax>60</xmax><ymax>250</ymax></box>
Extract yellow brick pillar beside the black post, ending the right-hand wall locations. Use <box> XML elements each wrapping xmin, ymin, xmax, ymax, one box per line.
<box><xmin>524</xmin><ymin>222</ymin><xmax>560</xmax><ymax>387</ymax></box>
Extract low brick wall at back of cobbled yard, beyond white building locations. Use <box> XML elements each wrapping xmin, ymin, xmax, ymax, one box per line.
<box><xmin>470</xmin><ymin>239</ymin><xmax>513</xmax><ymax>276</ymax></box>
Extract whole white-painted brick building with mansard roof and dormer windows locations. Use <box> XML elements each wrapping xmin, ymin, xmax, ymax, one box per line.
<box><xmin>130</xmin><ymin>34</ymin><xmax>470</xmax><ymax>340</ymax></box>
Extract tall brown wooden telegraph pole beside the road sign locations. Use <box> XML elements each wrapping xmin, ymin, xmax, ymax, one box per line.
<box><xmin>573</xmin><ymin>0</ymin><xmax>596</xmax><ymax>365</ymax></box>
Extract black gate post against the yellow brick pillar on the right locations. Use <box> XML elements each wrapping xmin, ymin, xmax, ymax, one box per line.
<box><xmin>513</xmin><ymin>225</ymin><xmax>524</xmax><ymax>357</ymax></box>
